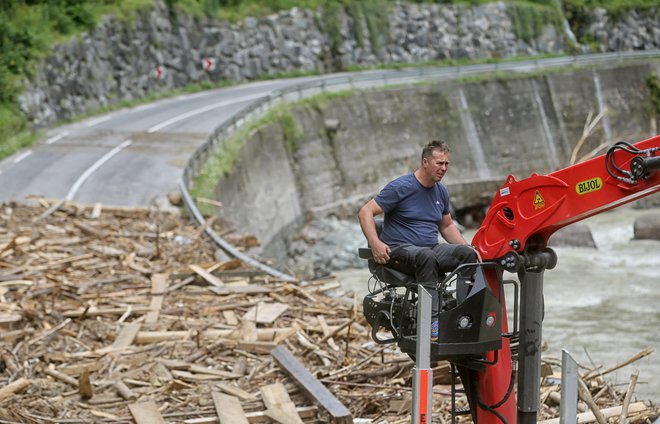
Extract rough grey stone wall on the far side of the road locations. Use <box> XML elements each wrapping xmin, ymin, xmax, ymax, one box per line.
<box><xmin>19</xmin><ymin>0</ymin><xmax>660</xmax><ymax>126</ymax></box>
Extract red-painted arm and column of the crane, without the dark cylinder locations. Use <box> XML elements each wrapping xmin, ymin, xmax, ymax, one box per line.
<box><xmin>471</xmin><ymin>136</ymin><xmax>660</xmax><ymax>424</ymax></box>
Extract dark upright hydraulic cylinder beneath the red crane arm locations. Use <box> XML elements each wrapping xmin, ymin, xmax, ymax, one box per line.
<box><xmin>518</xmin><ymin>270</ymin><xmax>543</xmax><ymax>424</ymax></box>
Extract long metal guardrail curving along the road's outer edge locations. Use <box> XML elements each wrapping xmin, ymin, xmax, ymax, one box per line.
<box><xmin>179</xmin><ymin>50</ymin><xmax>660</xmax><ymax>281</ymax></box>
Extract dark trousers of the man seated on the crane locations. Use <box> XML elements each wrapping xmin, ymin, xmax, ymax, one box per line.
<box><xmin>387</xmin><ymin>243</ymin><xmax>477</xmax><ymax>319</ymax></box>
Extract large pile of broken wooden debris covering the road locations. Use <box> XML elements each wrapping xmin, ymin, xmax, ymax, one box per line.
<box><xmin>0</xmin><ymin>204</ymin><xmax>655</xmax><ymax>424</ymax></box>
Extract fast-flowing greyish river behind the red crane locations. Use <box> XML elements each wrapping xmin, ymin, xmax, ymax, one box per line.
<box><xmin>335</xmin><ymin>207</ymin><xmax>660</xmax><ymax>403</ymax></box>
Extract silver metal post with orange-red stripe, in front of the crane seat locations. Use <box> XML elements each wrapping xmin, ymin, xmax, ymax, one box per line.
<box><xmin>412</xmin><ymin>286</ymin><xmax>433</xmax><ymax>424</ymax></box>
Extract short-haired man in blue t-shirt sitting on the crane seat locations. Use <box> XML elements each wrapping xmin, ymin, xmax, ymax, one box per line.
<box><xmin>358</xmin><ymin>141</ymin><xmax>478</xmax><ymax>339</ymax></box>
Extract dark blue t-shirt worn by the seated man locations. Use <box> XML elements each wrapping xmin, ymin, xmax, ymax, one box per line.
<box><xmin>374</xmin><ymin>173</ymin><xmax>449</xmax><ymax>246</ymax></box>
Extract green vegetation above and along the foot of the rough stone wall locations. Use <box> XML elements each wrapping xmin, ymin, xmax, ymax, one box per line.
<box><xmin>0</xmin><ymin>0</ymin><xmax>658</xmax><ymax>158</ymax></box>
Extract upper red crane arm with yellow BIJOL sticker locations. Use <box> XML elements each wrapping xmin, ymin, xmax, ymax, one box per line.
<box><xmin>472</xmin><ymin>136</ymin><xmax>660</xmax><ymax>260</ymax></box>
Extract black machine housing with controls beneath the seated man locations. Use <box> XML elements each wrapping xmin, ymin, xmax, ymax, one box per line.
<box><xmin>359</xmin><ymin>248</ymin><xmax>502</xmax><ymax>368</ymax></box>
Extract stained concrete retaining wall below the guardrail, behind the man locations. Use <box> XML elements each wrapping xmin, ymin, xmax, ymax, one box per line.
<box><xmin>216</xmin><ymin>62</ymin><xmax>657</xmax><ymax>253</ymax></box>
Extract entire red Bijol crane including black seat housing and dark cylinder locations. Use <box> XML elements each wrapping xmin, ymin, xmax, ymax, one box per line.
<box><xmin>360</xmin><ymin>136</ymin><xmax>660</xmax><ymax>424</ymax></box>
